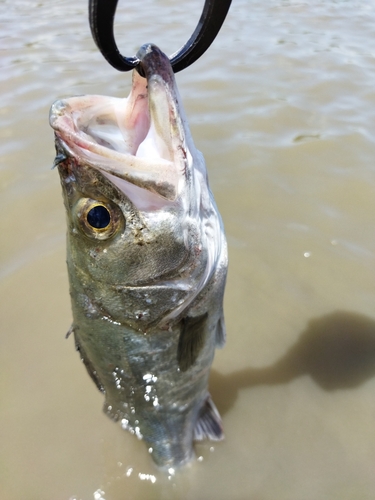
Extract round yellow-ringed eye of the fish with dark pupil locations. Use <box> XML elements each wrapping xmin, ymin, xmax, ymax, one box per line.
<box><xmin>75</xmin><ymin>198</ymin><xmax>124</xmax><ymax>240</ymax></box>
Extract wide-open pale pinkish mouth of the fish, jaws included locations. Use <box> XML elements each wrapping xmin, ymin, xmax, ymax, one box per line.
<box><xmin>50</xmin><ymin>45</ymin><xmax>193</xmax><ymax>210</ymax></box>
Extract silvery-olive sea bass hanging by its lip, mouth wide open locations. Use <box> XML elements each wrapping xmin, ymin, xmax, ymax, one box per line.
<box><xmin>50</xmin><ymin>44</ymin><xmax>227</xmax><ymax>467</ymax></box>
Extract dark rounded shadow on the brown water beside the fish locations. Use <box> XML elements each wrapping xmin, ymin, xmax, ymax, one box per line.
<box><xmin>210</xmin><ymin>311</ymin><xmax>375</xmax><ymax>415</ymax></box>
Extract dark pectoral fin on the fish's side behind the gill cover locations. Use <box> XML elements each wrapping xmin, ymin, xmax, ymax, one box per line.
<box><xmin>177</xmin><ymin>313</ymin><xmax>208</xmax><ymax>372</ymax></box>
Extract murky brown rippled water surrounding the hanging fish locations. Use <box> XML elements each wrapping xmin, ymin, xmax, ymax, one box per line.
<box><xmin>0</xmin><ymin>0</ymin><xmax>375</xmax><ymax>500</ymax></box>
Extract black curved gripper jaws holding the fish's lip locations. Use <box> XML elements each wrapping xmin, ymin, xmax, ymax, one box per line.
<box><xmin>89</xmin><ymin>0</ymin><xmax>232</xmax><ymax>73</ymax></box>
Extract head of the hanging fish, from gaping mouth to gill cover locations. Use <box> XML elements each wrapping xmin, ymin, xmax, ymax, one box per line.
<box><xmin>50</xmin><ymin>45</ymin><xmax>223</xmax><ymax>326</ymax></box>
